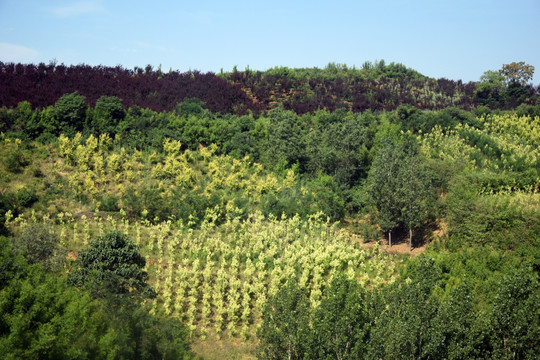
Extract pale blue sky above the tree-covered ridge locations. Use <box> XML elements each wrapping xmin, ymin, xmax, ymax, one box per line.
<box><xmin>0</xmin><ymin>0</ymin><xmax>540</xmax><ymax>84</ymax></box>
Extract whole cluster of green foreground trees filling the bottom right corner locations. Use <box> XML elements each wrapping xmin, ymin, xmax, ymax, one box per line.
<box><xmin>258</xmin><ymin>257</ymin><xmax>540</xmax><ymax>359</ymax></box>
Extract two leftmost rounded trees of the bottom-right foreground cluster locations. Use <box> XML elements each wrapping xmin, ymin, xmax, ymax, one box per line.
<box><xmin>257</xmin><ymin>275</ymin><xmax>369</xmax><ymax>359</ymax></box>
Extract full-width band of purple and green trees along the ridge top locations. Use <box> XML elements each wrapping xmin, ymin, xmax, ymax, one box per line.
<box><xmin>0</xmin><ymin>60</ymin><xmax>539</xmax><ymax>114</ymax></box>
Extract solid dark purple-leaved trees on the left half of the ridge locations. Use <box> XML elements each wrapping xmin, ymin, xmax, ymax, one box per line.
<box><xmin>0</xmin><ymin>63</ymin><xmax>249</xmax><ymax>113</ymax></box>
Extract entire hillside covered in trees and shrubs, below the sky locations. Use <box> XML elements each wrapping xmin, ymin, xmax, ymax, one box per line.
<box><xmin>0</xmin><ymin>61</ymin><xmax>540</xmax><ymax>359</ymax></box>
